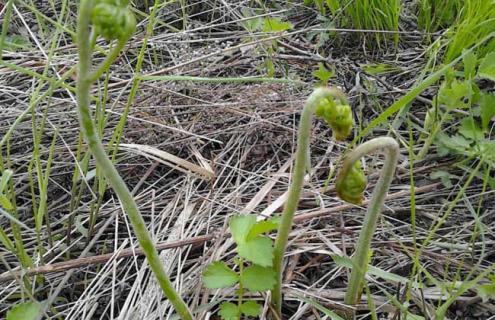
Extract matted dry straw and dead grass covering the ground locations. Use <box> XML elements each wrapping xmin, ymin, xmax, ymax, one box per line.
<box><xmin>0</xmin><ymin>0</ymin><xmax>495</xmax><ymax>319</ymax></box>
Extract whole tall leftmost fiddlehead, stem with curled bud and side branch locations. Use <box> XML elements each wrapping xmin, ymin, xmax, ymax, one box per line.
<box><xmin>76</xmin><ymin>0</ymin><xmax>193</xmax><ymax>320</ymax></box>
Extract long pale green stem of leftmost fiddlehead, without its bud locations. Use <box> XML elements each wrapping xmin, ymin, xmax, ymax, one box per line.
<box><xmin>77</xmin><ymin>0</ymin><xmax>193</xmax><ymax>320</ymax></box>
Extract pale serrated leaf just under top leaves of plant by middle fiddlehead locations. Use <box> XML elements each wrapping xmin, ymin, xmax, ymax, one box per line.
<box><xmin>237</xmin><ymin>236</ymin><xmax>273</xmax><ymax>267</ymax></box>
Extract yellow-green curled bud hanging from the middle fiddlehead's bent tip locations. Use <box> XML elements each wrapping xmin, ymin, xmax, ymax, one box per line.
<box><xmin>315</xmin><ymin>99</ymin><xmax>354</xmax><ymax>140</ymax></box>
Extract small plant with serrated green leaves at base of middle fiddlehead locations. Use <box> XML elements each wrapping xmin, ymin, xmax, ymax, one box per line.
<box><xmin>203</xmin><ymin>215</ymin><xmax>278</xmax><ymax>320</ymax></box>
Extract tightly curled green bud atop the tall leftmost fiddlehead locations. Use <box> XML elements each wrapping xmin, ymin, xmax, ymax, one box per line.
<box><xmin>91</xmin><ymin>0</ymin><xmax>136</xmax><ymax>41</ymax></box>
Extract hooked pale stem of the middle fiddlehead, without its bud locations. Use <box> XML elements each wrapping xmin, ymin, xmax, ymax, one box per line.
<box><xmin>272</xmin><ymin>88</ymin><xmax>347</xmax><ymax>318</ymax></box>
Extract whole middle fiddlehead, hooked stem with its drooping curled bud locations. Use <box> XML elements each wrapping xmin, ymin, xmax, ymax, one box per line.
<box><xmin>272</xmin><ymin>87</ymin><xmax>353</xmax><ymax>318</ymax></box>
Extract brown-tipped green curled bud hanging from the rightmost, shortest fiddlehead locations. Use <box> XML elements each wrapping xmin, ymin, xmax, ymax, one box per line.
<box><xmin>335</xmin><ymin>161</ymin><xmax>368</xmax><ymax>204</ymax></box>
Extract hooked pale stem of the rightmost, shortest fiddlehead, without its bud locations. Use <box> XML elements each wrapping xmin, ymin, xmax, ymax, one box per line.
<box><xmin>339</xmin><ymin>137</ymin><xmax>399</xmax><ymax>305</ymax></box>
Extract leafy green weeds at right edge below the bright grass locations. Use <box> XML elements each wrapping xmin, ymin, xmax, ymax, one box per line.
<box><xmin>418</xmin><ymin>53</ymin><xmax>495</xmax><ymax>159</ymax></box>
